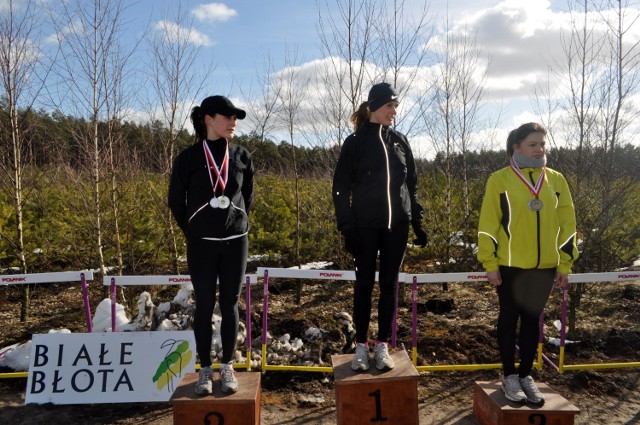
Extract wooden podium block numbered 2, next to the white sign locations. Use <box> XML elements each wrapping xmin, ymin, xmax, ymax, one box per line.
<box><xmin>169</xmin><ymin>372</ymin><xmax>261</xmax><ymax>425</ymax></box>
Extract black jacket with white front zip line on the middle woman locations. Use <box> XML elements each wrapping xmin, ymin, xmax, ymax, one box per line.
<box><xmin>333</xmin><ymin>122</ymin><xmax>422</xmax><ymax>231</ymax></box>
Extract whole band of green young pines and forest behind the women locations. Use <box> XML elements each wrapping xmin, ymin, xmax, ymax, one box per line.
<box><xmin>0</xmin><ymin>107</ymin><xmax>640</xmax><ymax>334</ymax></box>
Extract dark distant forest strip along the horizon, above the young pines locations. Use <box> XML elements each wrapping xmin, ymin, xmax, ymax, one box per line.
<box><xmin>6</xmin><ymin>106</ymin><xmax>640</xmax><ymax>181</ymax></box>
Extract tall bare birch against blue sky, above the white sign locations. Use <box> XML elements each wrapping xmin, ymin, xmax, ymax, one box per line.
<box><xmin>52</xmin><ymin>0</ymin><xmax>134</xmax><ymax>275</ymax></box>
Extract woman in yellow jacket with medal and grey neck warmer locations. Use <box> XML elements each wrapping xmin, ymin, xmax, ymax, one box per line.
<box><xmin>478</xmin><ymin>123</ymin><xmax>578</xmax><ymax>405</ymax></box>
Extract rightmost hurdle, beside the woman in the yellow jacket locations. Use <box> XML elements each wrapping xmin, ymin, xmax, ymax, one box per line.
<box><xmin>558</xmin><ymin>271</ymin><xmax>640</xmax><ymax>373</ymax></box>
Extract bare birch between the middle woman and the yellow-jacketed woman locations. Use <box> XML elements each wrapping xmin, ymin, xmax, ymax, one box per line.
<box><xmin>421</xmin><ymin>19</ymin><xmax>489</xmax><ymax>271</ymax></box>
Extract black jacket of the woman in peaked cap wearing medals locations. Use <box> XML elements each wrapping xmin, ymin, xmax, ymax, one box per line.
<box><xmin>168</xmin><ymin>139</ymin><xmax>254</xmax><ymax>239</ymax></box>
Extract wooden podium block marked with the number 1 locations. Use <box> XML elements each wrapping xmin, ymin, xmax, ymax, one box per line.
<box><xmin>331</xmin><ymin>350</ymin><xmax>419</xmax><ymax>425</ymax></box>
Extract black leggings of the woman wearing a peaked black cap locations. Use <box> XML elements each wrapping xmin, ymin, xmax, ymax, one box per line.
<box><xmin>187</xmin><ymin>236</ymin><xmax>249</xmax><ymax>367</ymax></box>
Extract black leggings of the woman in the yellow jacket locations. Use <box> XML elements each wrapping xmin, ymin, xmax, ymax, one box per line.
<box><xmin>497</xmin><ymin>267</ymin><xmax>556</xmax><ymax>378</ymax></box>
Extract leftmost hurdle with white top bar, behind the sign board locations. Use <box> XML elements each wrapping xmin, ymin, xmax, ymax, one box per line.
<box><xmin>0</xmin><ymin>270</ymin><xmax>93</xmax><ymax>378</ymax></box>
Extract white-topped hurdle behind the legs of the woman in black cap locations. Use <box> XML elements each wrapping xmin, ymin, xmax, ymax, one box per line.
<box><xmin>102</xmin><ymin>274</ymin><xmax>258</xmax><ymax>370</ymax></box>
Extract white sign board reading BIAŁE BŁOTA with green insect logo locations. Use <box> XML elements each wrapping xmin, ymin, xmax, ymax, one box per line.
<box><xmin>25</xmin><ymin>331</ymin><xmax>196</xmax><ymax>404</ymax></box>
